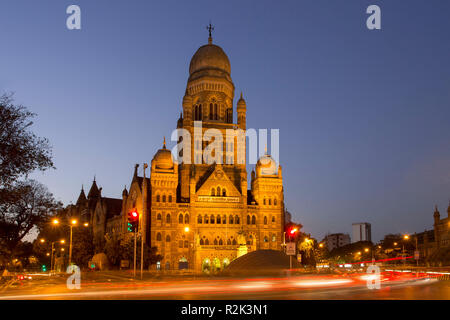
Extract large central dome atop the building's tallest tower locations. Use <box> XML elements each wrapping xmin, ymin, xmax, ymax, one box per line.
<box><xmin>189</xmin><ymin>43</ymin><xmax>231</xmax><ymax>75</ymax></box>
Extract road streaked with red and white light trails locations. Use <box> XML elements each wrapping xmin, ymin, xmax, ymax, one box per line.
<box><xmin>0</xmin><ymin>273</ymin><xmax>450</xmax><ymax>300</ymax></box>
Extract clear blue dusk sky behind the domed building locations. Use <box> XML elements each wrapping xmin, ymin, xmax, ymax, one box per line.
<box><xmin>0</xmin><ymin>0</ymin><xmax>450</xmax><ymax>240</ymax></box>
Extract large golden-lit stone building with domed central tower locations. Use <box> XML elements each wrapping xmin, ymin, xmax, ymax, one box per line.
<box><xmin>67</xmin><ymin>34</ymin><xmax>285</xmax><ymax>272</ymax></box>
